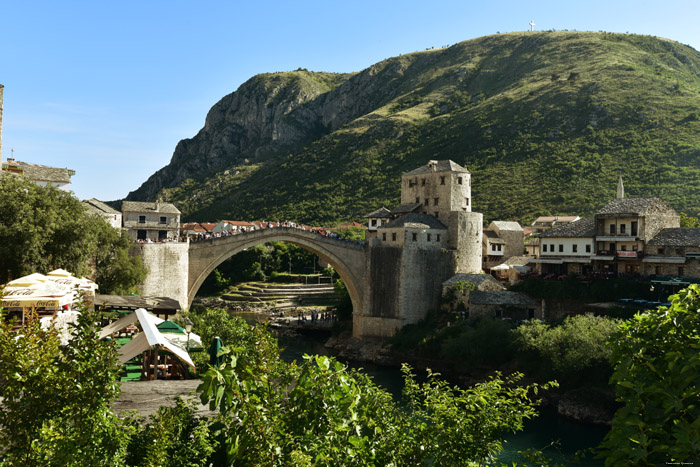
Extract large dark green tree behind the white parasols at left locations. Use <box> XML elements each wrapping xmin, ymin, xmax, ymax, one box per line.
<box><xmin>0</xmin><ymin>174</ymin><xmax>146</xmax><ymax>293</ymax></box>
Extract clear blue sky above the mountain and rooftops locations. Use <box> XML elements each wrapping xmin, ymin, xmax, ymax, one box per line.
<box><xmin>0</xmin><ymin>0</ymin><xmax>700</xmax><ymax>200</ymax></box>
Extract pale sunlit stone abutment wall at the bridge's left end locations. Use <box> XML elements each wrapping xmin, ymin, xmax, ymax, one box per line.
<box><xmin>129</xmin><ymin>243</ymin><xmax>189</xmax><ymax>307</ymax></box>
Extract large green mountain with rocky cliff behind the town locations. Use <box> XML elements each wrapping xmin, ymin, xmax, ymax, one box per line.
<box><xmin>127</xmin><ymin>31</ymin><xmax>700</xmax><ymax>223</ymax></box>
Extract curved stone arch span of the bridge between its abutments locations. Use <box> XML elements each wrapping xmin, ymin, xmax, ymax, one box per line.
<box><xmin>187</xmin><ymin>227</ymin><xmax>366</xmax><ymax>324</ymax></box>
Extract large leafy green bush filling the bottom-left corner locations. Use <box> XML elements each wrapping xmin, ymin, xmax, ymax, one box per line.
<box><xmin>0</xmin><ymin>298</ymin><xmax>129</xmax><ymax>466</ymax></box>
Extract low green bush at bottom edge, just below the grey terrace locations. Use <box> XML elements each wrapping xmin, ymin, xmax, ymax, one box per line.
<box><xmin>126</xmin><ymin>397</ymin><xmax>216</xmax><ymax>467</ymax></box>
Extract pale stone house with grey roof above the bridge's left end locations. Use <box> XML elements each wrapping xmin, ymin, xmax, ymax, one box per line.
<box><xmin>122</xmin><ymin>201</ymin><xmax>180</xmax><ymax>242</ymax></box>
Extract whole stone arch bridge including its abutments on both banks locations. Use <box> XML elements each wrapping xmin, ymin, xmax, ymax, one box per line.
<box><xmin>131</xmin><ymin>227</ymin><xmax>468</xmax><ymax>338</ymax></box>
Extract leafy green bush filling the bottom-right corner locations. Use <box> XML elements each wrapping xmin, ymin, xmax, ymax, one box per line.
<box><xmin>601</xmin><ymin>285</ymin><xmax>700</xmax><ymax>466</ymax></box>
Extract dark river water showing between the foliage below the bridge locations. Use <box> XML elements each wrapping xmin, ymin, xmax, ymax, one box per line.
<box><xmin>278</xmin><ymin>335</ymin><xmax>608</xmax><ymax>467</ymax></box>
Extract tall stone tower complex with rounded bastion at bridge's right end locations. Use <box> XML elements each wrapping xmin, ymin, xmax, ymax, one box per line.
<box><xmin>358</xmin><ymin>160</ymin><xmax>483</xmax><ymax>335</ymax></box>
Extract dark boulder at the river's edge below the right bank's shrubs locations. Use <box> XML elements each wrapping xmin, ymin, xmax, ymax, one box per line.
<box><xmin>557</xmin><ymin>388</ymin><xmax>618</xmax><ymax>426</ymax></box>
